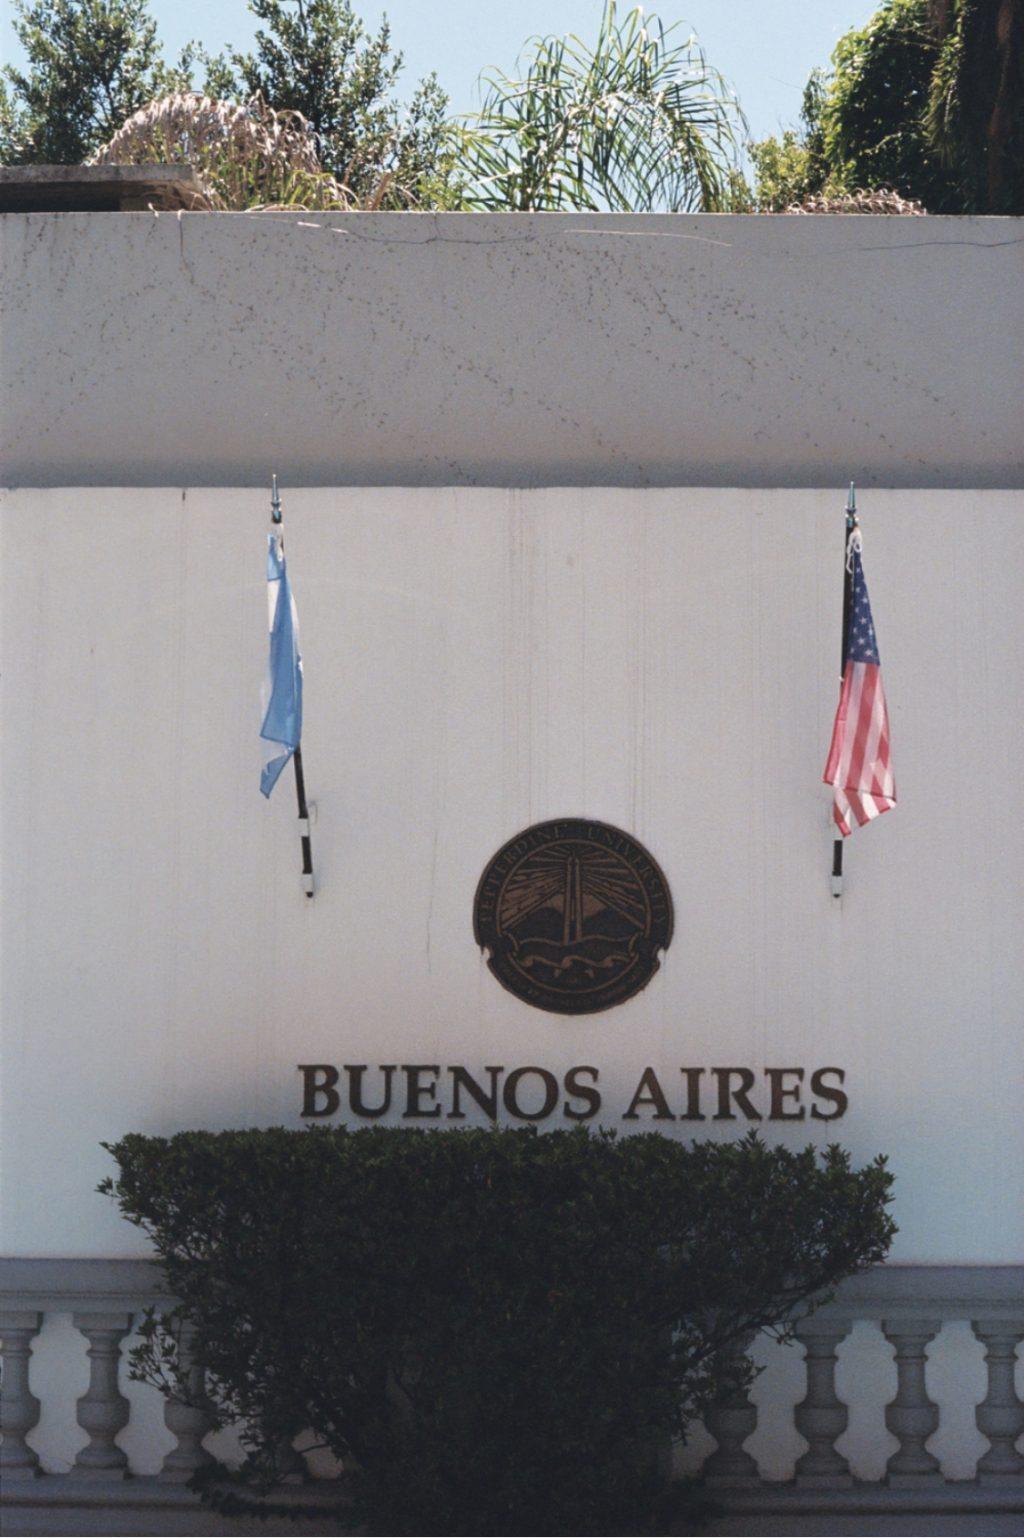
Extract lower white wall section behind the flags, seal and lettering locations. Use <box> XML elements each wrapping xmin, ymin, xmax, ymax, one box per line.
<box><xmin>2</xmin><ymin>486</ymin><xmax>1024</xmax><ymax>1263</ymax></box>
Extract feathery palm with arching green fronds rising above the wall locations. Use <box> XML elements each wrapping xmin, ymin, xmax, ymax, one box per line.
<box><xmin>460</xmin><ymin>0</ymin><xmax>743</xmax><ymax>212</ymax></box>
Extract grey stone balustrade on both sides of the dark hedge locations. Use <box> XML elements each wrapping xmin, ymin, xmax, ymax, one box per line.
<box><xmin>0</xmin><ymin>1260</ymin><xmax>1024</xmax><ymax>1532</ymax></box>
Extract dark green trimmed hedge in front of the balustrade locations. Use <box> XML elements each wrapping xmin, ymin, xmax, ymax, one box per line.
<box><xmin>100</xmin><ymin>1127</ymin><xmax>895</xmax><ymax>1533</ymax></box>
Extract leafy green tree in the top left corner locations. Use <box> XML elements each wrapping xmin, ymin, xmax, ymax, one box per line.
<box><xmin>0</xmin><ymin>0</ymin><xmax>189</xmax><ymax>165</ymax></box>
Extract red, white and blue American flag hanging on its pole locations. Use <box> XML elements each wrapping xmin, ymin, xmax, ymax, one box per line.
<box><xmin>824</xmin><ymin>526</ymin><xmax>896</xmax><ymax>838</ymax></box>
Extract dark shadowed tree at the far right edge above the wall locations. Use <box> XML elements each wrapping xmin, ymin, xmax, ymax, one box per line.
<box><xmin>926</xmin><ymin>0</ymin><xmax>1024</xmax><ymax>214</ymax></box>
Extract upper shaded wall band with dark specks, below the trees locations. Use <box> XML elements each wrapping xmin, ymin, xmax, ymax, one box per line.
<box><xmin>0</xmin><ymin>214</ymin><xmax>1024</xmax><ymax>488</ymax></box>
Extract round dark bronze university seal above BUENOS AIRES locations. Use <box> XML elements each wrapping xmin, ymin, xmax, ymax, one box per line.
<box><xmin>474</xmin><ymin>817</ymin><xmax>672</xmax><ymax>1015</ymax></box>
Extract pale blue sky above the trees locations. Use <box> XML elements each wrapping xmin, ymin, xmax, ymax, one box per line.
<box><xmin>0</xmin><ymin>0</ymin><xmax>875</xmax><ymax>138</ymax></box>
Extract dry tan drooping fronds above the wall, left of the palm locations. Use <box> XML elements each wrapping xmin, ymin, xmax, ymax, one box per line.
<box><xmin>91</xmin><ymin>91</ymin><xmax>360</xmax><ymax>209</ymax></box>
